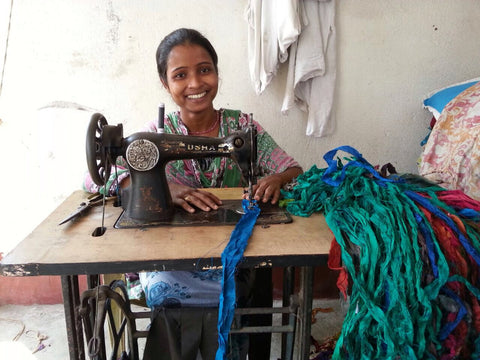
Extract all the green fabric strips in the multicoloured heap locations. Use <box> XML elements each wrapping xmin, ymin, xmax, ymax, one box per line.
<box><xmin>282</xmin><ymin>155</ymin><xmax>480</xmax><ymax>360</ymax></box>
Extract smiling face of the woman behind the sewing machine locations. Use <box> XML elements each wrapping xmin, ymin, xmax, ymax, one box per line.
<box><xmin>163</xmin><ymin>44</ymin><xmax>218</xmax><ymax>113</ymax></box>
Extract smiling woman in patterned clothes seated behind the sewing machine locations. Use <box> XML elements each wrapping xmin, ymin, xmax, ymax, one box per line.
<box><xmin>81</xmin><ymin>28</ymin><xmax>302</xmax><ymax>360</ymax></box>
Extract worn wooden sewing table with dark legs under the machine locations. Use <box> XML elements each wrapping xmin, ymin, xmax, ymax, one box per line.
<box><xmin>0</xmin><ymin>188</ymin><xmax>333</xmax><ymax>360</ymax></box>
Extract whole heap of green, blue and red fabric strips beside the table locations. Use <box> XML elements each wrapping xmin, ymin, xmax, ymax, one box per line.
<box><xmin>283</xmin><ymin>146</ymin><xmax>480</xmax><ymax>360</ymax></box>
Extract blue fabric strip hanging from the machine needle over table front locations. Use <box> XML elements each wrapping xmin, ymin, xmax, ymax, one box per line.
<box><xmin>215</xmin><ymin>200</ymin><xmax>260</xmax><ymax>360</ymax></box>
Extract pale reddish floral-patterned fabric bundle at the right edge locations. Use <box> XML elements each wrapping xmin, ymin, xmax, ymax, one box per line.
<box><xmin>419</xmin><ymin>83</ymin><xmax>480</xmax><ymax>200</ymax></box>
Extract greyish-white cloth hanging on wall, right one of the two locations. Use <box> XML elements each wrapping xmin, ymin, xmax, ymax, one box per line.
<box><xmin>282</xmin><ymin>0</ymin><xmax>336</xmax><ymax>137</ymax></box>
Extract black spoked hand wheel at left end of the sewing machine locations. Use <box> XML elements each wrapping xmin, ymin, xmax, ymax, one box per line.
<box><xmin>86</xmin><ymin>113</ymin><xmax>111</xmax><ymax>186</ymax></box>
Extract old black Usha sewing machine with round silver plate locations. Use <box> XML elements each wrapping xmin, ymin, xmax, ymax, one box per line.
<box><xmin>86</xmin><ymin>111</ymin><xmax>291</xmax><ymax>228</ymax></box>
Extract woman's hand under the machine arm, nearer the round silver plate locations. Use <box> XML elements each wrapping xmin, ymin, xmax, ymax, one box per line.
<box><xmin>168</xmin><ymin>183</ymin><xmax>222</xmax><ymax>213</ymax></box>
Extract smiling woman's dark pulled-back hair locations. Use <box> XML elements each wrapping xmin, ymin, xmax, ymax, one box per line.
<box><xmin>156</xmin><ymin>28</ymin><xmax>218</xmax><ymax>84</ymax></box>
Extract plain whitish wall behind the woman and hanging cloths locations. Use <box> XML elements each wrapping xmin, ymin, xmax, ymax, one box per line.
<box><xmin>0</xmin><ymin>0</ymin><xmax>480</xmax><ymax>251</ymax></box>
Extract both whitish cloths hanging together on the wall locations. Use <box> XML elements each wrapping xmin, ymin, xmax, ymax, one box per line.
<box><xmin>246</xmin><ymin>0</ymin><xmax>336</xmax><ymax>137</ymax></box>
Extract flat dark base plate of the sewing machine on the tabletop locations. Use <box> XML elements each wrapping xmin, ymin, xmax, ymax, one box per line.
<box><xmin>115</xmin><ymin>200</ymin><xmax>292</xmax><ymax>229</ymax></box>
